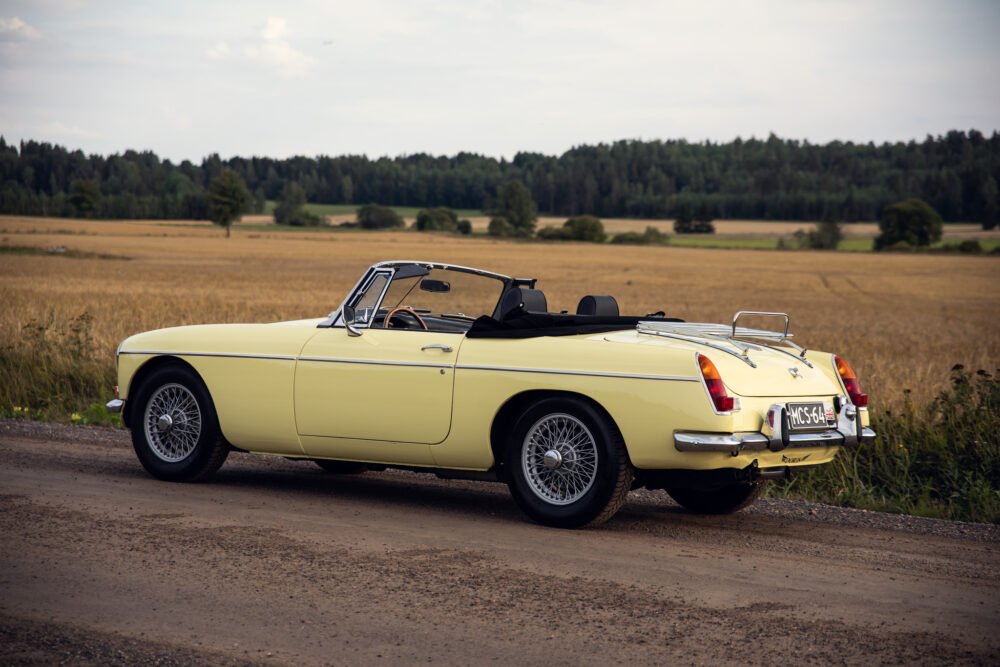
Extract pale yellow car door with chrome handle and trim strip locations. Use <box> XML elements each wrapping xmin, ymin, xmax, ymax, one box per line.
<box><xmin>295</xmin><ymin>327</ymin><xmax>464</xmax><ymax>448</ymax></box>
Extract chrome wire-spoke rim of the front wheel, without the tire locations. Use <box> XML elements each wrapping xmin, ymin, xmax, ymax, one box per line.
<box><xmin>143</xmin><ymin>383</ymin><xmax>202</xmax><ymax>463</ymax></box>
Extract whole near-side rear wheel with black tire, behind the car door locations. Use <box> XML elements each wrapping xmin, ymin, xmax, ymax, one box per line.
<box><xmin>504</xmin><ymin>397</ymin><xmax>634</xmax><ymax>528</ymax></box>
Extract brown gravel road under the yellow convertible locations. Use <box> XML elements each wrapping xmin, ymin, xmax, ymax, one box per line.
<box><xmin>0</xmin><ymin>421</ymin><xmax>1000</xmax><ymax>665</ymax></box>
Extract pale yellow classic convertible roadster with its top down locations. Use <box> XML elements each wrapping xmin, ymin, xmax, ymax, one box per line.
<box><xmin>108</xmin><ymin>261</ymin><xmax>875</xmax><ymax>527</ymax></box>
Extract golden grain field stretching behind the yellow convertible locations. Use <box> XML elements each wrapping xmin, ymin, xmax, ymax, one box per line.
<box><xmin>0</xmin><ymin>216</ymin><xmax>1000</xmax><ymax>407</ymax></box>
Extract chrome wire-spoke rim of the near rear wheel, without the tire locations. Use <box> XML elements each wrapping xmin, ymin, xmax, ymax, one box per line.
<box><xmin>521</xmin><ymin>413</ymin><xmax>598</xmax><ymax>505</ymax></box>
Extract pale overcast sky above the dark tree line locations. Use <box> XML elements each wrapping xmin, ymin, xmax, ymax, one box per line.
<box><xmin>0</xmin><ymin>0</ymin><xmax>1000</xmax><ymax>161</ymax></box>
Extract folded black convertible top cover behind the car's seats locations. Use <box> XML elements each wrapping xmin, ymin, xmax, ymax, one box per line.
<box><xmin>466</xmin><ymin>310</ymin><xmax>683</xmax><ymax>338</ymax></box>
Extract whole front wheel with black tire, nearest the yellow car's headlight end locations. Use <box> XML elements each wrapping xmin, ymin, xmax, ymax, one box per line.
<box><xmin>130</xmin><ymin>365</ymin><xmax>229</xmax><ymax>482</ymax></box>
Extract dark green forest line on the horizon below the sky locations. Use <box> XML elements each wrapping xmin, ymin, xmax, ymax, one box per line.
<box><xmin>0</xmin><ymin>130</ymin><xmax>1000</xmax><ymax>227</ymax></box>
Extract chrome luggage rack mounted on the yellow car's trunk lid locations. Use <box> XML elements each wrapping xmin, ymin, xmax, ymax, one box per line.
<box><xmin>636</xmin><ymin>310</ymin><xmax>813</xmax><ymax>368</ymax></box>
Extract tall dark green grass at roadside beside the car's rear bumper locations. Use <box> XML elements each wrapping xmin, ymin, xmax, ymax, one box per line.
<box><xmin>773</xmin><ymin>365</ymin><xmax>1000</xmax><ymax>523</ymax></box>
